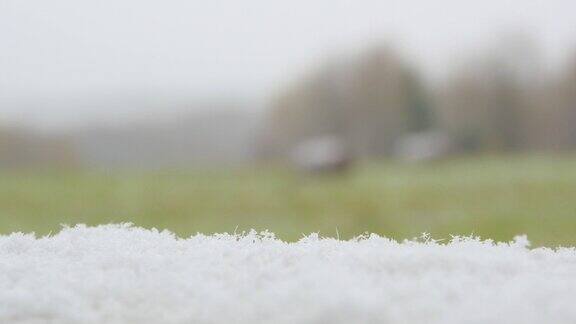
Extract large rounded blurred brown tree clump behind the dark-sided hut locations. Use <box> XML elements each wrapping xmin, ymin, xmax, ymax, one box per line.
<box><xmin>265</xmin><ymin>47</ymin><xmax>432</xmax><ymax>161</ymax></box>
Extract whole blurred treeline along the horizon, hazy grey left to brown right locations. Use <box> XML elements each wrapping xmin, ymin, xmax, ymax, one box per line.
<box><xmin>0</xmin><ymin>36</ymin><xmax>576</xmax><ymax>168</ymax></box>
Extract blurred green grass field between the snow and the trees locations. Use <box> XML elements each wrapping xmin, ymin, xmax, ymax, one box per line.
<box><xmin>0</xmin><ymin>156</ymin><xmax>576</xmax><ymax>246</ymax></box>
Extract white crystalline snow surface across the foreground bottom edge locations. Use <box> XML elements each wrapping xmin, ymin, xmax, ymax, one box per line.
<box><xmin>0</xmin><ymin>225</ymin><xmax>576</xmax><ymax>324</ymax></box>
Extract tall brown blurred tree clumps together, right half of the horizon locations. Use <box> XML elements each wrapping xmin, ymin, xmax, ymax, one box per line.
<box><xmin>260</xmin><ymin>37</ymin><xmax>576</xmax><ymax>158</ymax></box>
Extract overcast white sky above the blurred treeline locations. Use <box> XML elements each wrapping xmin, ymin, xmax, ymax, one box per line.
<box><xmin>0</xmin><ymin>0</ymin><xmax>576</xmax><ymax>129</ymax></box>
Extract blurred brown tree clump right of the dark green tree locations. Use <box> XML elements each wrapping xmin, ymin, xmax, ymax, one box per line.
<box><xmin>439</xmin><ymin>35</ymin><xmax>539</xmax><ymax>151</ymax></box>
